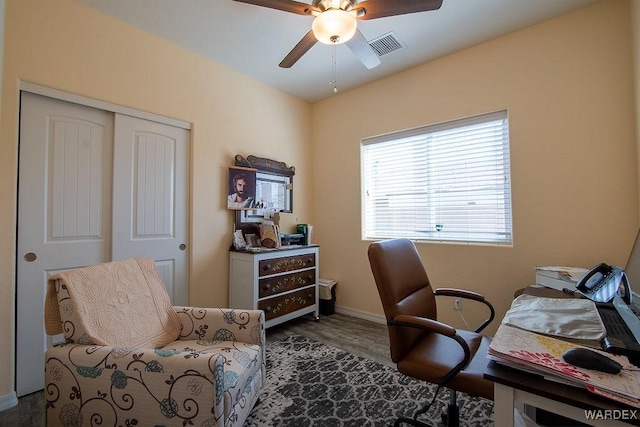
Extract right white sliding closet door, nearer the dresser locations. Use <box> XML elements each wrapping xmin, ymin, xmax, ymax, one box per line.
<box><xmin>113</xmin><ymin>114</ymin><xmax>189</xmax><ymax>305</ymax></box>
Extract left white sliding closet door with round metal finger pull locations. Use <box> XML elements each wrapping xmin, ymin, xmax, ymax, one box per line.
<box><xmin>16</xmin><ymin>93</ymin><xmax>113</xmax><ymax>396</ymax></box>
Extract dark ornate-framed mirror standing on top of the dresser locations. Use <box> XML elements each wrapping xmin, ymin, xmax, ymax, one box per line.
<box><xmin>235</xmin><ymin>154</ymin><xmax>296</xmax><ymax>232</ymax></box>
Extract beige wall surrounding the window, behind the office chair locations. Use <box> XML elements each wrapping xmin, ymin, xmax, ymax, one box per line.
<box><xmin>312</xmin><ymin>0</ymin><xmax>638</xmax><ymax>328</ymax></box>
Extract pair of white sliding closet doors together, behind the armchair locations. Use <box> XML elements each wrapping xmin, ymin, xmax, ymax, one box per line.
<box><xmin>16</xmin><ymin>92</ymin><xmax>190</xmax><ymax>396</ymax></box>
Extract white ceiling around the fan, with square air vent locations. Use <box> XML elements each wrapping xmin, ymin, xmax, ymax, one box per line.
<box><xmin>77</xmin><ymin>0</ymin><xmax>597</xmax><ymax>102</ymax></box>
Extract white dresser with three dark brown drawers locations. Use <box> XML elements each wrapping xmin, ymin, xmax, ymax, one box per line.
<box><xmin>229</xmin><ymin>245</ymin><xmax>319</xmax><ymax>328</ymax></box>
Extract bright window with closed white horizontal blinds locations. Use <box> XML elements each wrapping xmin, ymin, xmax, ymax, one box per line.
<box><xmin>361</xmin><ymin>111</ymin><xmax>511</xmax><ymax>244</ymax></box>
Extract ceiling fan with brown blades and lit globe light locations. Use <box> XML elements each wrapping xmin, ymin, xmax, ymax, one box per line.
<box><xmin>235</xmin><ymin>0</ymin><xmax>443</xmax><ymax>69</ymax></box>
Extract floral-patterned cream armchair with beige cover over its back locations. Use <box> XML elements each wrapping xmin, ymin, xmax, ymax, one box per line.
<box><xmin>44</xmin><ymin>258</ymin><xmax>265</xmax><ymax>427</ymax></box>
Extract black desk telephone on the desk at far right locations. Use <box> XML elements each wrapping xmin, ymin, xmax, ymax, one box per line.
<box><xmin>576</xmin><ymin>263</ymin><xmax>631</xmax><ymax>304</ymax></box>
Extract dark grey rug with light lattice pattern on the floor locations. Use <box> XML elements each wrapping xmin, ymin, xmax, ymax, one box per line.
<box><xmin>245</xmin><ymin>335</ymin><xmax>493</xmax><ymax>427</ymax></box>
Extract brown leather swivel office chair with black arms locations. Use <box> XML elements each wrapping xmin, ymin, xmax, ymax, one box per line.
<box><xmin>368</xmin><ymin>239</ymin><xmax>495</xmax><ymax>426</ymax></box>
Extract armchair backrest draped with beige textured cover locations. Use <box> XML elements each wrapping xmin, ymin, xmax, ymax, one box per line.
<box><xmin>45</xmin><ymin>258</ymin><xmax>180</xmax><ymax>348</ymax></box>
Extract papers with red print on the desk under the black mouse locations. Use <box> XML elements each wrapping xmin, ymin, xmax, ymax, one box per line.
<box><xmin>488</xmin><ymin>324</ymin><xmax>640</xmax><ymax>408</ymax></box>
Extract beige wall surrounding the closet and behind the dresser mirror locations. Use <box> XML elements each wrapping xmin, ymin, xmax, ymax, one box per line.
<box><xmin>0</xmin><ymin>0</ymin><xmax>312</xmax><ymax>398</ymax></box>
